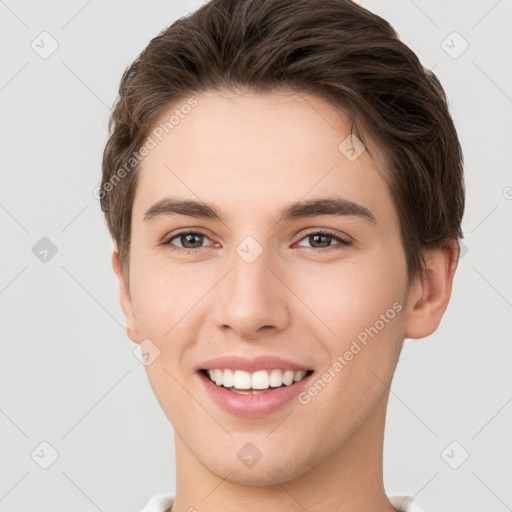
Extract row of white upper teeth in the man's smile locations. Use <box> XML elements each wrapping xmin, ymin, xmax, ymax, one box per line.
<box><xmin>203</xmin><ymin>368</ymin><xmax>307</xmax><ymax>390</ymax></box>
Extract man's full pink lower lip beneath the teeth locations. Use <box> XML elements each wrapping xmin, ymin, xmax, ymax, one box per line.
<box><xmin>198</xmin><ymin>372</ymin><xmax>313</xmax><ymax>418</ymax></box>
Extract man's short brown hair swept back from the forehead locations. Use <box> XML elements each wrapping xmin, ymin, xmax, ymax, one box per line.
<box><xmin>99</xmin><ymin>0</ymin><xmax>465</xmax><ymax>281</ymax></box>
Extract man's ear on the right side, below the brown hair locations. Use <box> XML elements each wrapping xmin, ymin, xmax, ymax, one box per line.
<box><xmin>404</xmin><ymin>241</ymin><xmax>459</xmax><ymax>338</ymax></box>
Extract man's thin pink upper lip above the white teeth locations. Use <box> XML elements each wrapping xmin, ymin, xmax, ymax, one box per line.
<box><xmin>197</xmin><ymin>355</ymin><xmax>312</xmax><ymax>372</ymax></box>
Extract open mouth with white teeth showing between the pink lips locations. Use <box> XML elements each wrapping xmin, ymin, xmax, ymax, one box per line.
<box><xmin>199</xmin><ymin>368</ymin><xmax>313</xmax><ymax>395</ymax></box>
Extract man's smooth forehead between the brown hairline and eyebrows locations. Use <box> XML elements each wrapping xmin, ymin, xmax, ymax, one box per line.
<box><xmin>134</xmin><ymin>91</ymin><xmax>392</xmax><ymax>224</ymax></box>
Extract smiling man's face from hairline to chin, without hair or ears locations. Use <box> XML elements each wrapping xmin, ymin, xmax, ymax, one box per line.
<box><xmin>117</xmin><ymin>91</ymin><xmax>416</xmax><ymax>485</ymax></box>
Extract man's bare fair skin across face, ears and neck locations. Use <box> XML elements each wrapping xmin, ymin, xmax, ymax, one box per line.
<box><xmin>112</xmin><ymin>91</ymin><xmax>458</xmax><ymax>512</ymax></box>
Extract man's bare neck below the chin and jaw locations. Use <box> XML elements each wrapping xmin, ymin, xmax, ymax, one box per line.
<box><xmin>172</xmin><ymin>394</ymin><xmax>396</xmax><ymax>512</ymax></box>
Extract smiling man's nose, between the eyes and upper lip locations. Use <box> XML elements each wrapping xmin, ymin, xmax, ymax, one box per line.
<box><xmin>214</xmin><ymin>243</ymin><xmax>290</xmax><ymax>340</ymax></box>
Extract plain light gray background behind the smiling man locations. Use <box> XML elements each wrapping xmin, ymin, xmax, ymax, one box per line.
<box><xmin>0</xmin><ymin>0</ymin><xmax>512</xmax><ymax>512</ymax></box>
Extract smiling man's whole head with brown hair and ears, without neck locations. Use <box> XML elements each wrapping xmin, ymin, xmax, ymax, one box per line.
<box><xmin>99</xmin><ymin>0</ymin><xmax>464</xmax><ymax>484</ymax></box>
